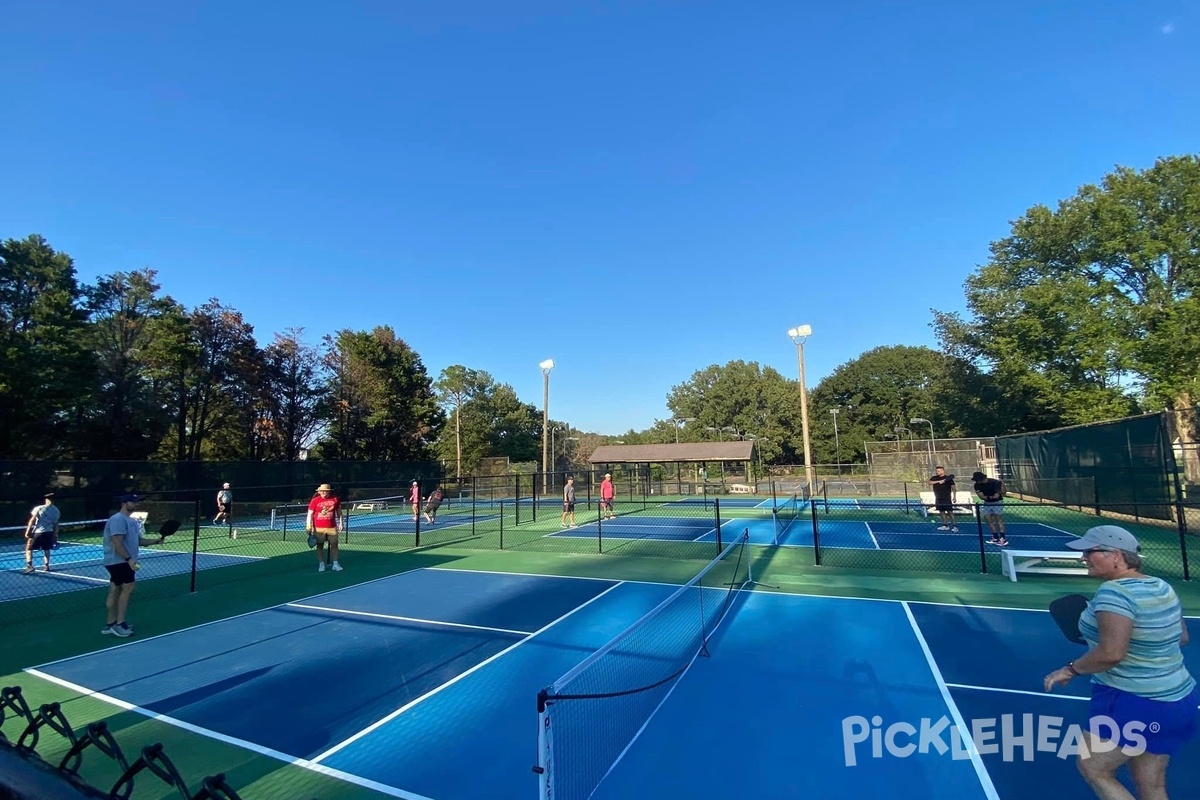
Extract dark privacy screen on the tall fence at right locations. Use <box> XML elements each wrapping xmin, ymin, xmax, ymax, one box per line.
<box><xmin>996</xmin><ymin>414</ymin><xmax>1175</xmax><ymax>519</ymax></box>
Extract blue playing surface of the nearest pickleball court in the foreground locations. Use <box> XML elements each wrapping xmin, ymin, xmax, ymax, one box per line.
<box><xmin>21</xmin><ymin>569</ymin><xmax>1200</xmax><ymax>800</ymax></box>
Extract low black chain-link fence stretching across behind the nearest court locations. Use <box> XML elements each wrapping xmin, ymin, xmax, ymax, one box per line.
<box><xmin>0</xmin><ymin>471</ymin><xmax>1190</xmax><ymax>627</ymax></box>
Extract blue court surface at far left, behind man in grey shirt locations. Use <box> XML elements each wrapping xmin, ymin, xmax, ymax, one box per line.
<box><xmin>0</xmin><ymin>540</ymin><xmax>259</xmax><ymax>599</ymax></box>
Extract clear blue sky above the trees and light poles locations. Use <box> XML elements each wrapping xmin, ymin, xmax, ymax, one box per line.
<box><xmin>0</xmin><ymin>0</ymin><xmax>1200</xmax><ymax>433</ymax></box>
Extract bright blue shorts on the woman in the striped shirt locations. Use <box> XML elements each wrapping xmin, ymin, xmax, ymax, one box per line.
<box><xmin>1087</xmin><ymin>684</ymin><xmax>1200</xmax><ymax>756</ymax></box>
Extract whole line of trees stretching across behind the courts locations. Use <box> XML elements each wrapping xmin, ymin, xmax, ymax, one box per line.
<box><xmin>0</xmin><ymin>156</ymin><xmax>1200</xmax><ymax>474</ymax></box>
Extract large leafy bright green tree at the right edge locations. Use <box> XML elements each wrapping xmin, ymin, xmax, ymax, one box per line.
<box><xmin>935</xmin><ymin>156</ymin><xmax>1200</xmax><ymax>429</ymax></box>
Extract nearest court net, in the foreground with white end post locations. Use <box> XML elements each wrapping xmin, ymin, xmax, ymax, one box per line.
<box><xmin>534</xmin><ymin>534</ymin><xmax>751</xmax><ymax>800</ymax></box>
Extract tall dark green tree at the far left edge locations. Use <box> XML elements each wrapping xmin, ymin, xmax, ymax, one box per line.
<box><xmin>0</xmin><ymin>236</ymin><xmax>96</xmax><ymax>458</ymax></box>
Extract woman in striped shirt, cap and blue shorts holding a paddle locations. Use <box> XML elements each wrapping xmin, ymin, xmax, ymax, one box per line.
<box><xmin>1045</xmin><ymin>525</ymin><xmax>1200</xmax><ymax>800</ymax></box>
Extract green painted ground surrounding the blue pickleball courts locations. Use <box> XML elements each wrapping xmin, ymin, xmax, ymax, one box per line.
<box><xmin>0</xmin><ymin>499</ymin><xmax>1200</xmax><ymax>800</ymax></box>
